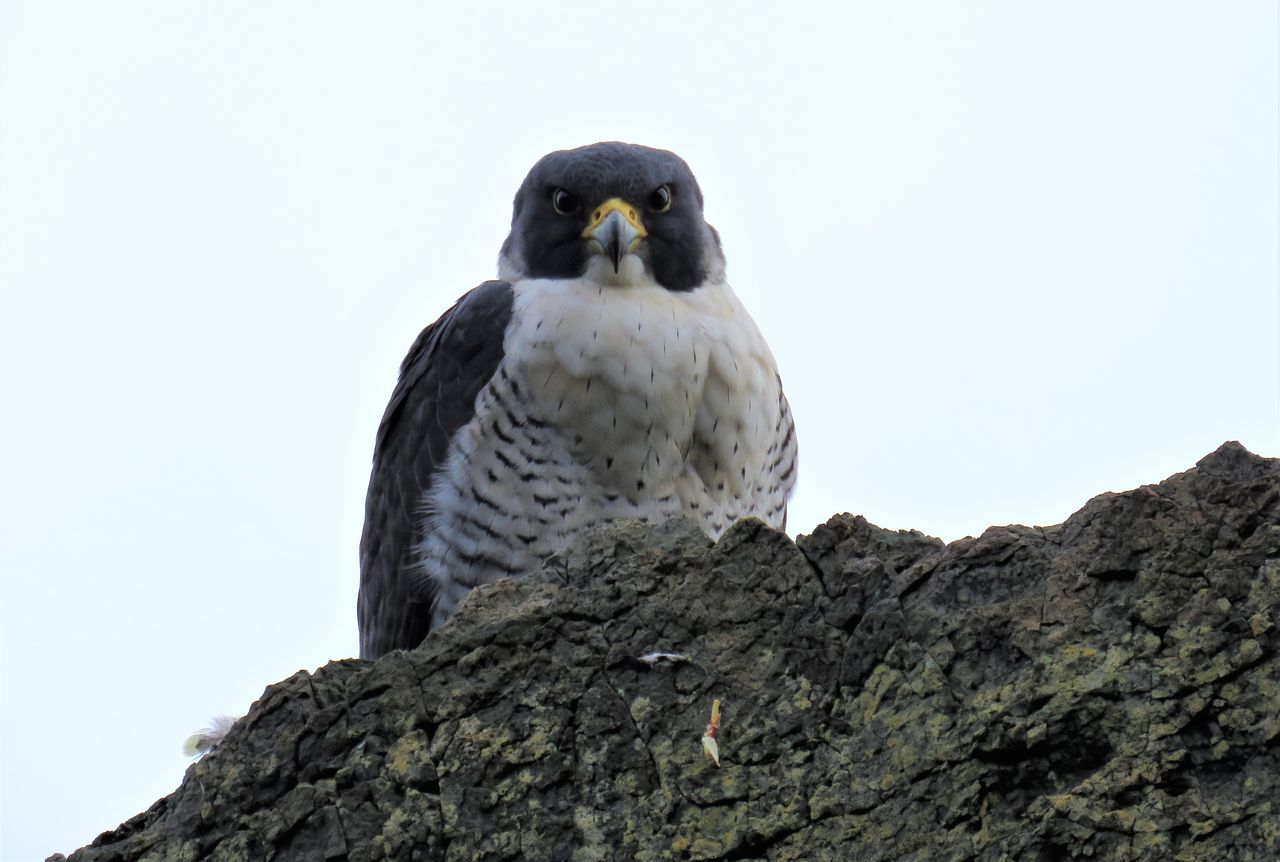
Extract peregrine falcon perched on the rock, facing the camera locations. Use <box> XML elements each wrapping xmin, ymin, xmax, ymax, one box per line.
<box><xmin>357</xmin><ymin>142</ymin><xmax>797</xmax><ymax>658</ymax></box>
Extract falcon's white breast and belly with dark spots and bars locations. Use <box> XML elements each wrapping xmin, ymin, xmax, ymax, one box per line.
<box><xmin>424</xmin><ymin>281</ymin><xmax>790</xmax><ymax>617</ymax></box>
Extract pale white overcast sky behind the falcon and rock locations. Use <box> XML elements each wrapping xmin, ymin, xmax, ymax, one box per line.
<box><xmin>0</xmin><ymin>0</ymin><xmax>1280</xmax><ymax>862</ymax></box>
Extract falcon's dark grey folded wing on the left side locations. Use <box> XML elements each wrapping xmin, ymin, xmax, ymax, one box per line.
<box><xmin>357</xmin><ymin>282</ymin><xmax>513</xmax><ymax>658</ymax></box>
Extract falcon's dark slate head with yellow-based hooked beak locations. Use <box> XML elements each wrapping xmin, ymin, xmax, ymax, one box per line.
<box><xmin>498</xmin><ymin>142</ymin><xmax>724</xmax><ymax>291</ymax></box>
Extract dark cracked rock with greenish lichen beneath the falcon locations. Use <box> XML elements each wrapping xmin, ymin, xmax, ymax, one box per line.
<box><xmin>57</xmin><ymin>443</ymin><xmax>1280</xmax><ymax>862</ymax></box>
